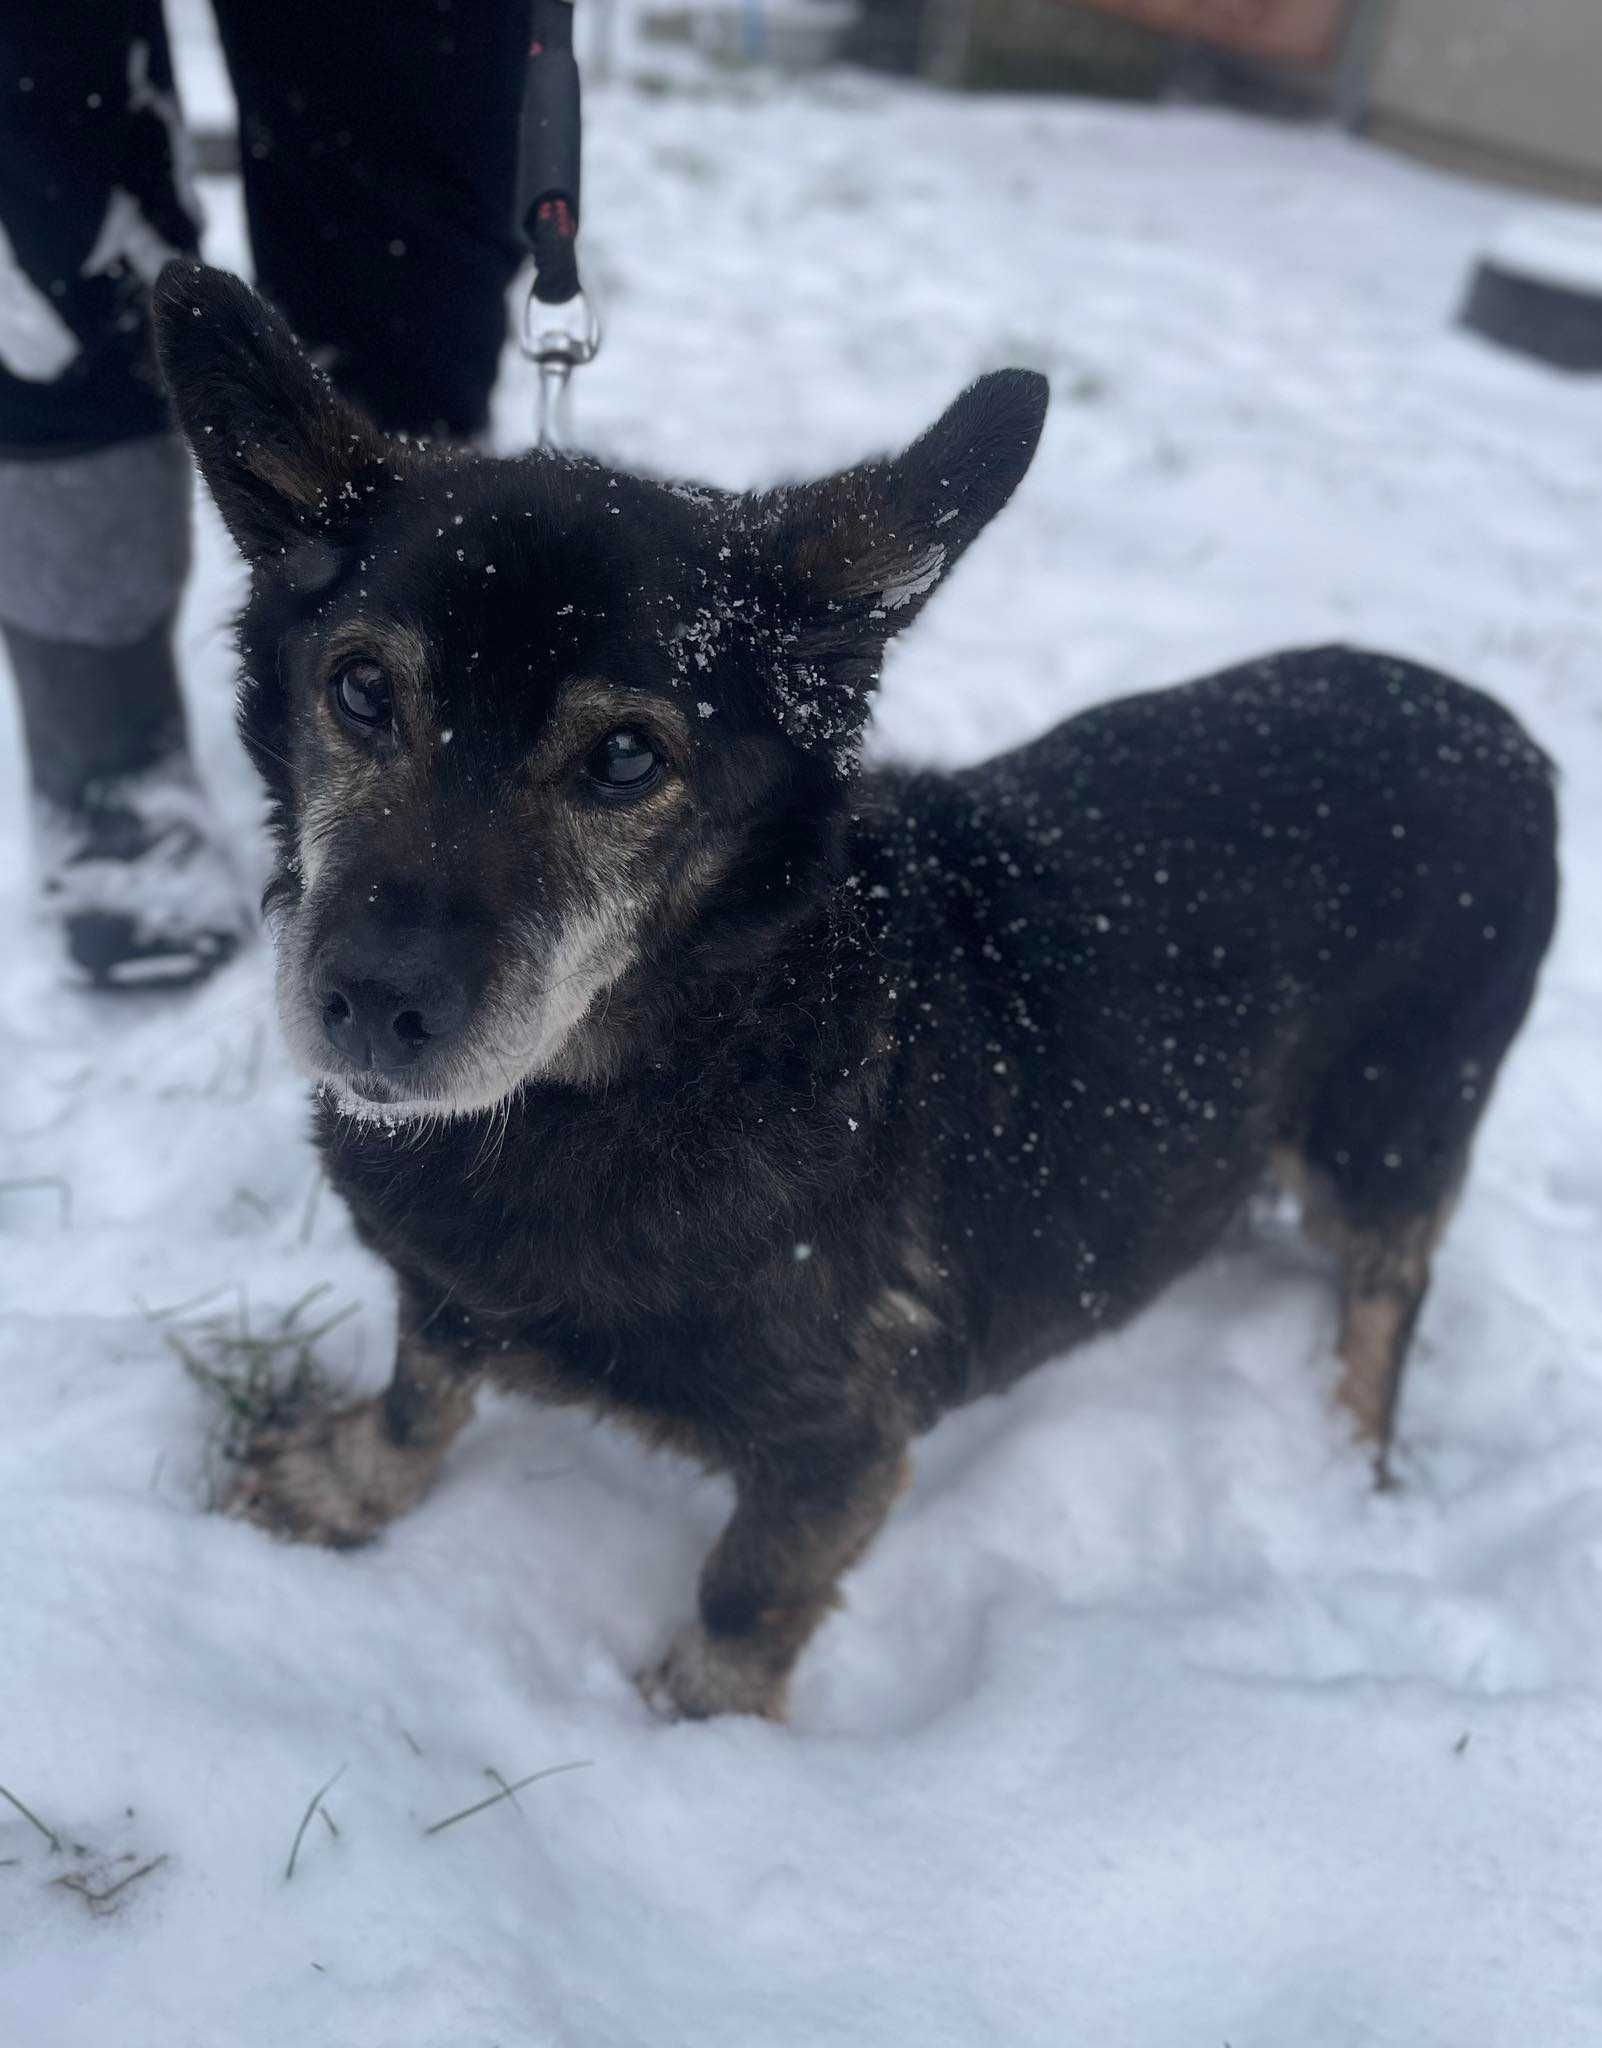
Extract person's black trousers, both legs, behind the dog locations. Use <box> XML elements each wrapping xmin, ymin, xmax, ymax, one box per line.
<box><xmin>0</xmin><ymin>0</ymin><xmax>529</xmax><ymax>457</ymax></box>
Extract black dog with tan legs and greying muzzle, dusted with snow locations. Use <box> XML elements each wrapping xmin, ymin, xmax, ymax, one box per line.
<box><xmin>156</xmin><ymin>262</ymin><xmax>1557</xmax><ymax>1718</ymax></box>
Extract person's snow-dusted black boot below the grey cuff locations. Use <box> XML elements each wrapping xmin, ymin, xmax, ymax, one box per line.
<box><xmin>0</xmin><ymin>618</ymin><xmax>250</xmax><ymax>993</ymax></box>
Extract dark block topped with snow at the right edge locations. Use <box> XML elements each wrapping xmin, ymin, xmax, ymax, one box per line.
<box><xmin>1459</xmin><ymin>217</ymin><xmax>1602</xmax><ymax>371</ymax></box>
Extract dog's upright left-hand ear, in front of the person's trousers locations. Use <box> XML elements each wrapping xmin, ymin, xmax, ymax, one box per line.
<box><xmin>154</xmin><ymin>260</ymin><xmax>395</xmax><ymax>563</ymax></box>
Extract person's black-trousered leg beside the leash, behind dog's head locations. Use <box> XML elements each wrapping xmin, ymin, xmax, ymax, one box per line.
<box><xmin>217</xmin><ymin>0</ymin><xmax>529</xmax><ymax>436</ymax></box>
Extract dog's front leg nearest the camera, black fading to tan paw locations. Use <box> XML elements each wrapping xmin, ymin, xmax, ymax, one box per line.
<box><xmin>639</xmin><ymin>1438</ymin><xmax>905</xmax><ymax>1720</ymax></box>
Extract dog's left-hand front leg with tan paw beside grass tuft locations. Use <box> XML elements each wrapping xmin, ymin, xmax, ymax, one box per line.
<box><xmin>225</xmin><ymin>1294</ymin><xmax>481</xmax><ymax>1548</ymax></box>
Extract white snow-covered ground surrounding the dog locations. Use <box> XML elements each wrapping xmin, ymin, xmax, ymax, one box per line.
<box><xmin>0</xmin><ymin>28</ymin><xmax>1602</xmax><ymax>2048</ymax></box>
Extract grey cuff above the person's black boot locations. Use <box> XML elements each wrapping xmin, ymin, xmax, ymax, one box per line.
<box><xmin>0</xmin><ymin>434</ymin><xmax>188</xmax><ymax>647</ymax></box>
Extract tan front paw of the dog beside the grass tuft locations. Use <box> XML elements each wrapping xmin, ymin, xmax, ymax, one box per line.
<box><xmin>223</xmin><ymin>1401</ymin><xmax>438</xmax><ymax>1550</ymax></box>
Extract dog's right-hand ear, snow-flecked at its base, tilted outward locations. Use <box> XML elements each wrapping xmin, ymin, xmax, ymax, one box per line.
<box><xmin>760</xmin><ymin>371</ymin><xmax>1049</xmax><ymax>743</ymax></box>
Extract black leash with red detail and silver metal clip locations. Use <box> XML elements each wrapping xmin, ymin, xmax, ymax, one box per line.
<box><xmin>516</xmin><ymin>0</ymin><xmax>600</xmax><ymax>449</ymax></box>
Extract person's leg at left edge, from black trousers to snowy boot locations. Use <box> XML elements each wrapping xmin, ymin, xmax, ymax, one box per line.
<box><xmin>0</xmin><ymin>0</ymin><xmax>242</xmax><ymax>987</ymax></box>
